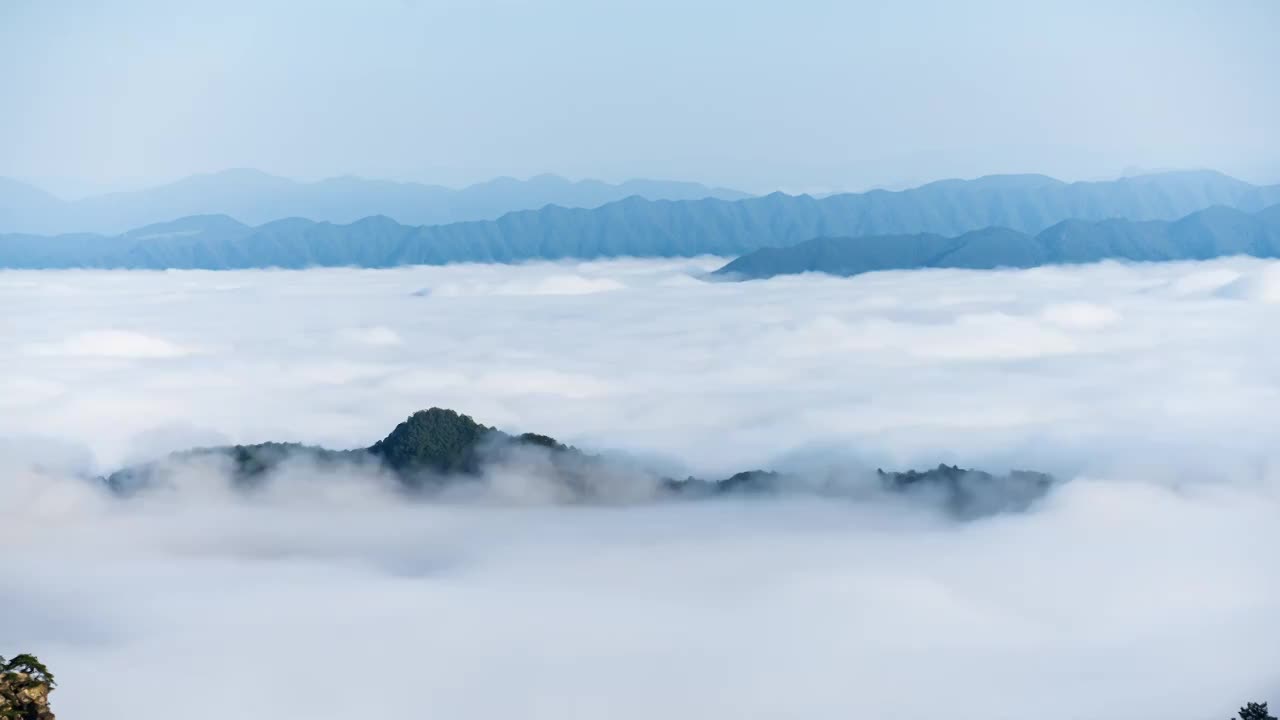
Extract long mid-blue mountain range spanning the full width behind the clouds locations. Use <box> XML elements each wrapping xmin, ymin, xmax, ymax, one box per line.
<box><xmin>0</xmin><ymin>172</ymin><xmax>1280</xmax><ymax>269</ymax></box>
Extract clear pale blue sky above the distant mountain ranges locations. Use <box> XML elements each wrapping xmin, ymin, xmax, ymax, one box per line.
<box><xmin>0</xmin><ymin>0</ymin><xmax>1280</xmax><ymax>192</ymax></box>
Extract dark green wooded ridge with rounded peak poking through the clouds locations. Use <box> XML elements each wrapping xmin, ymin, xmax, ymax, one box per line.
<box><xmin>102</xmin><ymin>407</ymin><xmax>1055</xmax><ymax>518</ymax></box>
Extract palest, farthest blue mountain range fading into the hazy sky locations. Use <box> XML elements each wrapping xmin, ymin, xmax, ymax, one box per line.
<box><xmin>0</xmin><ymin>169</ymin><xmax>749</xmax><ymax>234</ymax></box>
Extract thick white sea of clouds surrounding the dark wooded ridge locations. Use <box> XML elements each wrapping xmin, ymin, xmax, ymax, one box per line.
<box><xmin>0</xmin><ymin>259</ymin><xmax>1280</xmax><ymax>720</ymax></box>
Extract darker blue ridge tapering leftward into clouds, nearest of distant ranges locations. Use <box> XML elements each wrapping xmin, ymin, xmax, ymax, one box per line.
<box><xmin>713</xmin><ymin>205</ymin><xmax>1280</xmax><ymax>279</ymax></box>
